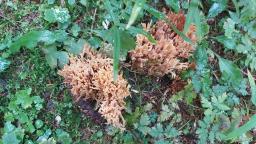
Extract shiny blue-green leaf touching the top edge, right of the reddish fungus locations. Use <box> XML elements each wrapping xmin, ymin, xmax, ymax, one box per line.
<box><xmin>207</xmin><ymin>0</ymin><xmax>227</xmax><ymax>18</ymax></box>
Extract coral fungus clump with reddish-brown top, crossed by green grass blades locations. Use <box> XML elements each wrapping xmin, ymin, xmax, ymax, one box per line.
<box><xmin>130</xmin><ymin>12</ymin><xmax>196</xmax><ymax>77</ymax></box>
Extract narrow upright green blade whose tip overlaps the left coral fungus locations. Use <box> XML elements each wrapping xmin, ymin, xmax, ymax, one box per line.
<box><xmin>112</xmin><ymin>26</ymin><xmax>121</xmax><ymax>81</ymax></box>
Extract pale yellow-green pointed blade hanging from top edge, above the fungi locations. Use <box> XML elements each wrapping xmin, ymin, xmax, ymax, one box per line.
<box><xmin>126</xmin><ymin>0</ymin><xmax>145</xmax><ymax>29</ymax></box>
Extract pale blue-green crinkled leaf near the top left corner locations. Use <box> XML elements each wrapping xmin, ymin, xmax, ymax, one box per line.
<box><xmin>44</xmin><ymin>7</ymin><xmax>70</xmax><ymax>23</ymax></box>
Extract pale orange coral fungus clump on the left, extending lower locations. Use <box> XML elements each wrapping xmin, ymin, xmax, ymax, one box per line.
<box><xmin>59</xmin><ymin>45</ymin><xmax>130</xmax><ymax>129</ymax></box>
